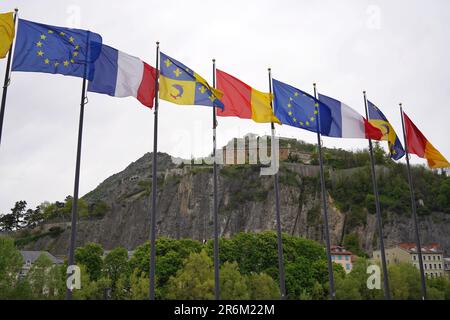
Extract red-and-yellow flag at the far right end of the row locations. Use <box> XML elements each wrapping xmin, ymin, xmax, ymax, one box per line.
<box><xmin>403</xmin><ymin>112</ymin><xmax>450</xmax><ymax>169</ymax></box>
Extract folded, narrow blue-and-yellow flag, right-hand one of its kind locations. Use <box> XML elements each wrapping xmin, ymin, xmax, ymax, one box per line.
<box><xmin>367</xmin><ymin>100</ymin><xmax>405</xmax><ymax>160</ymax></box>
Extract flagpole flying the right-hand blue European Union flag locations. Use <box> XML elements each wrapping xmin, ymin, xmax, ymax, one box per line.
<box><xmin>267</xmin><ymin>68</ymin><xmax>286</xmax><ymax>300</ymax></box>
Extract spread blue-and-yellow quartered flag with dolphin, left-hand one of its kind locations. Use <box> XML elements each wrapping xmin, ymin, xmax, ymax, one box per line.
<box><xmin>159</xmin><ymin>52</ymin><xmax>224</xmax><ymax>109</ymax></box>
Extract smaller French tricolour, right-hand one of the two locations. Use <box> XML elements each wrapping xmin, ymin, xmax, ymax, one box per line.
<box><xmin>319</xmin><ymin>94</ymin><xmax>383</xmax><ymax>140</ymax></box>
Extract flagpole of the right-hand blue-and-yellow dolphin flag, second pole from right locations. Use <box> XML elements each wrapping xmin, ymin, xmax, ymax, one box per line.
<box><xmin>363</xmin><ymin>91</ymin><xmax>391</xmax><ymax>300</ymax></box>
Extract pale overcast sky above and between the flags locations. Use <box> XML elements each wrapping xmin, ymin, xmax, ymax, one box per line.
<box><xmin>0</xmin><ymin>0</ymin><xmax>450</xmax><ymax>213</ymax></box>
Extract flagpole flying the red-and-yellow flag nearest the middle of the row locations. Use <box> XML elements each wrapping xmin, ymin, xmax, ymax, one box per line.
<box><xmin>212</xmin><ymin>59</ymin><xmax>220</xmax><ymax>300</ymax></box>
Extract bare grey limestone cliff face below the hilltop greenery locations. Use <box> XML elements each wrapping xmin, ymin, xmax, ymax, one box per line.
<box><xmin>23</xmin><ymin>153</ymin><xmax>450</xmax><ymax>255</ymax></box>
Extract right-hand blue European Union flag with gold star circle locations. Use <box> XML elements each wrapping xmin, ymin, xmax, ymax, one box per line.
<box><xmin>273</xmin><ymin>79</ymin><xmax>331</xmax><ymax>135</ymax></box>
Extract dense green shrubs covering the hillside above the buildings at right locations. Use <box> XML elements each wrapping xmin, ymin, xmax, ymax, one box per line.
<box><xmin>330</xmin><ymin>160</ymin><xmax>450</xmax><ymax>219</ymax></box>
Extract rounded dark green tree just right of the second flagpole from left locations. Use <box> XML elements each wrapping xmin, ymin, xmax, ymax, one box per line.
<box><xmin>75</xmin><ymin>242</ymin><xmax>103</xmax><ymax>281</ymax></box>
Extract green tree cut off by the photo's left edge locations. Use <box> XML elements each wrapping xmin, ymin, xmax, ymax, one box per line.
<box><xmin>0</xmin><ymin>237</ymin><xmax>23</xmax><ymax>299</ymax></box>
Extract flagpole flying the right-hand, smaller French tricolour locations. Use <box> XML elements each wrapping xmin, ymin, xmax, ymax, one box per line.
<box><xmin>313</xmin><ymin>83</ymin><xmax>336</xmax><ymax>300</ymax></box>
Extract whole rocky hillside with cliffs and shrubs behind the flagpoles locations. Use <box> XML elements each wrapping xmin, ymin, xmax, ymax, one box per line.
<box><xmin>10</xmin><ymin>139</ymin><xmax>450</xmax><ymax>254</ymax></box>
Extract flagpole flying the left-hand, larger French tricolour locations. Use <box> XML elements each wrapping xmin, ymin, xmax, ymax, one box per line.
<box><xmin>66</xmin><ymin>31</ymin><xmax>90</xmax><ymax>300</ymax></box>
